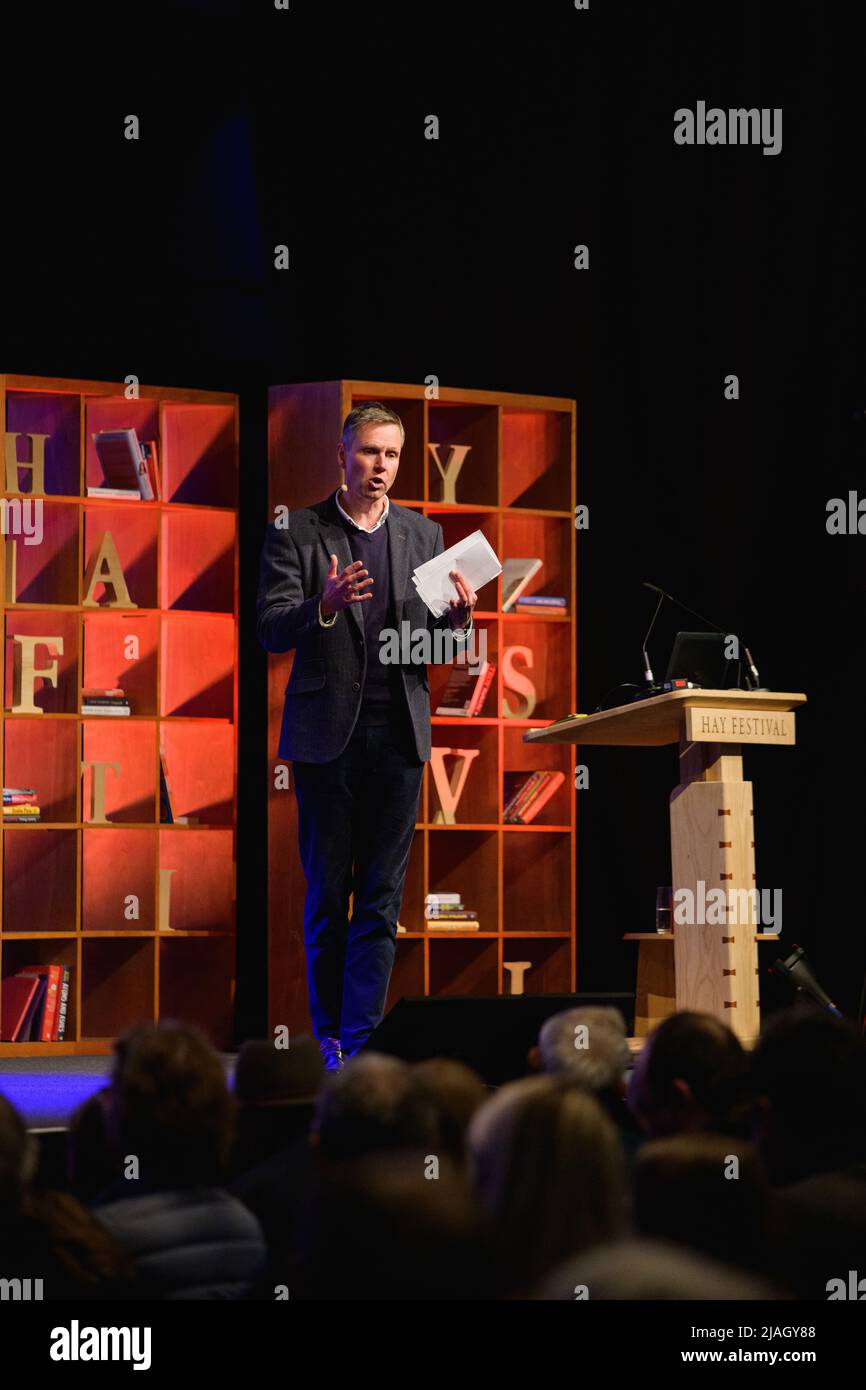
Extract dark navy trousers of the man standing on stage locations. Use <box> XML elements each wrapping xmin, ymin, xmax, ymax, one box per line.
<box><xmin>293</xmin><ymin>714</ymin><xmax>424</xmax><ymax>1056</ymax></box>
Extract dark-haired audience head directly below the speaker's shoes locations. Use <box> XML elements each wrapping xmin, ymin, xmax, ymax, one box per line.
<box><xmin>311</xmin><ymin>1052</ymin><xmax>436</xmax><ymax>1161</ymax></box>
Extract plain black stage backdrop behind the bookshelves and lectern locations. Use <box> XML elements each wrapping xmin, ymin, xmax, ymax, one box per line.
<box><xmin>0</xmin><ymin>0</ymin><xmax>866</xmax><ymax>1037</ymax></box>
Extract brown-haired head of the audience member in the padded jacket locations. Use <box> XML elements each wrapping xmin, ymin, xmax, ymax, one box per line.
<box><xmin>108</xmin><ymin>1022</ymin><xmax>235</xmax><ymax>1188</ymax></box>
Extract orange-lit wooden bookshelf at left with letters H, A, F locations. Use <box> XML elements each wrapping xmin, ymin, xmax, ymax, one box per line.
<box><xmin>0</xmin><ymin>375</ymin><xmax>238</xmax><ymax>1056</ymax></box>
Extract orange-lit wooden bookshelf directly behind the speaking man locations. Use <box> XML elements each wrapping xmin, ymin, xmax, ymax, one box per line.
<box><xmin>268</xmin><ymin>381</ymin><xmax>577</xmax><ymax>1031</ymax></box>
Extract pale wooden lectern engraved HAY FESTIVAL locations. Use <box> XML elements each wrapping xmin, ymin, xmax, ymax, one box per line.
<box><xmin>524</xmin><ymin>689</ymin><xmax>806</xmax><ymax>1043</ymax></box>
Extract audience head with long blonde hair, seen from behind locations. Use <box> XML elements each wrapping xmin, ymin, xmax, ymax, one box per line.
<box><xmin>470</xmin><ymin>1076</ymin><xmax>624</xmax><ymax>1287</ymax></box>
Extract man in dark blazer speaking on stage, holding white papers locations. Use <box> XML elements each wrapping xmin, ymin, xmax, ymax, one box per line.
<box><xmin>257</xmin><ymin>402</ymin><xmax>477</xmax><ymax>1070</ymax></box>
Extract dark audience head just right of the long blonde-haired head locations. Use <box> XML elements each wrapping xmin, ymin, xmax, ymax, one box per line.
<box><xmin>632</xmin><ymin>1134</ymin><xmax>769</xmax><ymax>1269</ymax></box>
